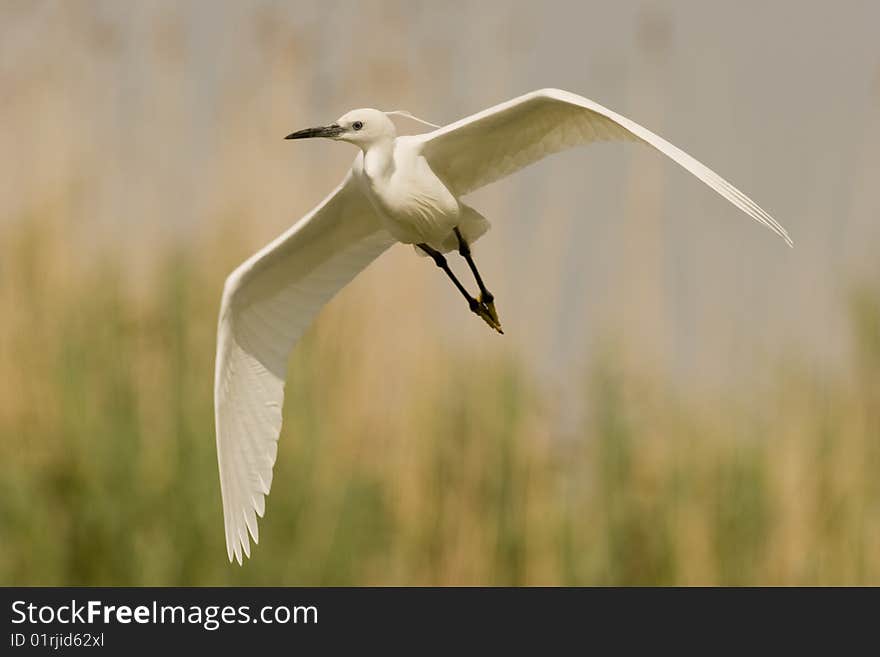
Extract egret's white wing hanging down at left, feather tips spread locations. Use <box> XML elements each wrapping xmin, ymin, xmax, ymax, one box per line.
<box><xmin>214</xmin><ymin>173</ymin><xmax>394</xmax><ymax>563</ymax></box>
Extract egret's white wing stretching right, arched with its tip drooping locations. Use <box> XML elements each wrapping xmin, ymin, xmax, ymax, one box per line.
<box><xmin>413</xmin><ymin>89</ymin><xmax>792</xmax><ymax>246</ymax></box>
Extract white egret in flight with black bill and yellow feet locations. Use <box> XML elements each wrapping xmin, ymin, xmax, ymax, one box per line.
<box><xmin>214</xmin><ymin>89</ymin><xmax>792</xmax><ymax>563</ymax></box>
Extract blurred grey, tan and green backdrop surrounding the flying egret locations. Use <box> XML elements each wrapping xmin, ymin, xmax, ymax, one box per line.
<box><xmin>0</xmin><ymin>0</ymin><xmax>880</xmax><ymax>585</ymax></box>
